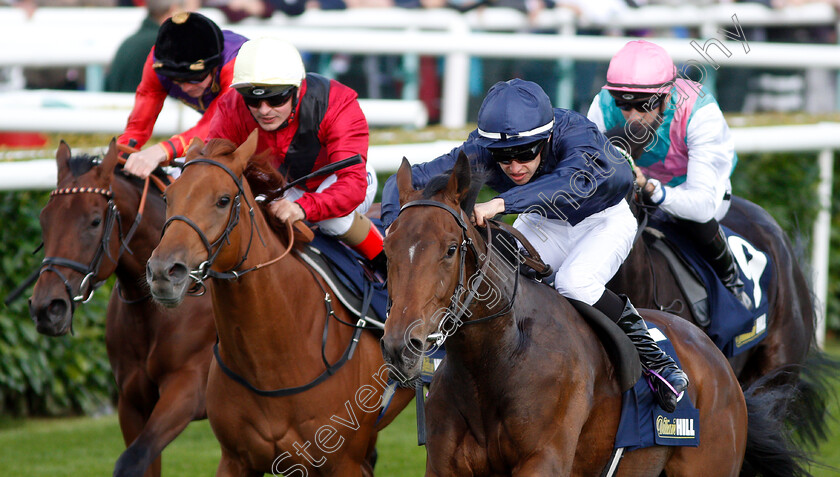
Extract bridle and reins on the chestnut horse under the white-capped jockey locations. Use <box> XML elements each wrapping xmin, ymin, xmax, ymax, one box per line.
<box><xmin>161</xmin><ymin>157</ymin><xmax>294</xmax><ymax>296</ymax></box>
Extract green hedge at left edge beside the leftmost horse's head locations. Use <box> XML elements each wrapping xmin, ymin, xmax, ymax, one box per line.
<box><xmin>0</xmin><ymin>192</ymin><xmax>115</xmax><ymax>415</ymax></box>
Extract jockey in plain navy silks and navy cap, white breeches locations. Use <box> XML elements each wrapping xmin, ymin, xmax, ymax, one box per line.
<box><xmin>382</xmin><ymin>79</ymin><xmax>688</xmax><ymax>412</ymax></box>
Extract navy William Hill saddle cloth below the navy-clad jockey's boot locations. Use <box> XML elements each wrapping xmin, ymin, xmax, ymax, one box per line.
<box><xmin>615</xmin><ymin>323</ymin><xmax>700</xmax><ymax>452</ymax></box>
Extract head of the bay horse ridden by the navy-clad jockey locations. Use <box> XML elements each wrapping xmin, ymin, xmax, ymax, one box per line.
<box><xmin>381</xmin><ymin>154</ymin><xmax>480</xmax><ymax>379</ymax></box>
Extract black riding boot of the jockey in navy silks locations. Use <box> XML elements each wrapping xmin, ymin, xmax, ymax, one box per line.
<box><xmin>618</xmin><ymin>297</ymin><xmax>688</xmax><ymax>412</ymax></box>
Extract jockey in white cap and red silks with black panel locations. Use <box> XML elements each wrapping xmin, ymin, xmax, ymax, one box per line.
<box><xmin>208</xmin><ymin>38</ymin><xmax>386</xmax><ymax>271</ymax></box>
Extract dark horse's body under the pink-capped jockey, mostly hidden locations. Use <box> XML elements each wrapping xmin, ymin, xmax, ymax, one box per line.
<box><xmin>608</xmin><ymin>197</ymin><xmax>816</xmax><ymax>386</ymax></box>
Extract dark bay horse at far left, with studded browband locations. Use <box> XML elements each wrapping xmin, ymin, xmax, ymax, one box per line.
<box><xmin>29</xmin><ymin>141</ymin><xmax>215</xmax><ymax>476</ymax></box>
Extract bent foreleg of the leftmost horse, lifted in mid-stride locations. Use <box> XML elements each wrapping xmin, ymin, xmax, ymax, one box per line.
<box><xmin>114</xmin><ymin>370</ymin><xmax>205</xmax><ymax>477</ymax></box>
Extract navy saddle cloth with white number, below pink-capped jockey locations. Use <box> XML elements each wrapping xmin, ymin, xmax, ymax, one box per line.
<box><xmin>648</xmin><ymin>220</ymin><xmax>773</xmax><ymax>357</ymax></box>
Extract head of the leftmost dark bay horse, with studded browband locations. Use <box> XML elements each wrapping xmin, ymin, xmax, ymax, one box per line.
<box><xmin>29</xmin><ymin>139</ymin><xmax>120</xmax><ymax>336</ymax></box>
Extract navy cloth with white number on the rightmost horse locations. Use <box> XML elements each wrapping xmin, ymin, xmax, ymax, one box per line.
<box><xmin>648</xmin><ymin>221</ymin><xmax>773</xmax><ymax>357</ymax></box>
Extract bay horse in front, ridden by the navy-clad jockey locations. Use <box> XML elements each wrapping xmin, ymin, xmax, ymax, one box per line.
<box><xmin>382</xmin><ymin>154</ymin><xmax>801</xmax><ymax>476</ymax></box>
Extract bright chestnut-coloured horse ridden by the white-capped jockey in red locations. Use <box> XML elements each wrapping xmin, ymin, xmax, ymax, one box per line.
<box><xmin>147</xmin><ymin>130</ymin><xmax>414</xmax><ymax>476</ymax></box>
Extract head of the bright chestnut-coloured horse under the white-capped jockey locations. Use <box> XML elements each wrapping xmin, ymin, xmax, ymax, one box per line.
<box><xmin>146</xmin><ymin>130</ymin><xmax>262</xmax><ymax>307</ymax></box>
